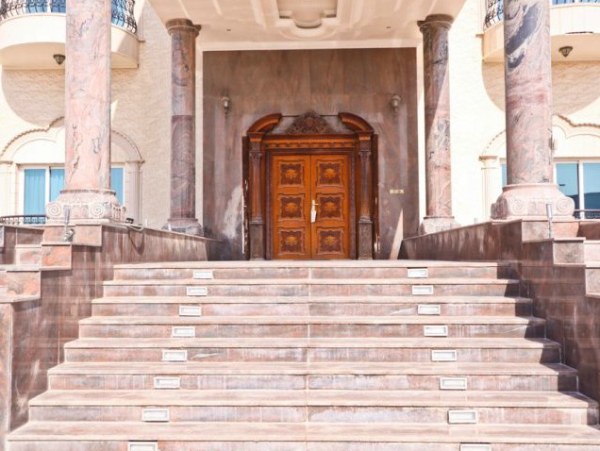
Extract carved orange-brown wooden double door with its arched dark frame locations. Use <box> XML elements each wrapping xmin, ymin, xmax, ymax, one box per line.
<box><xmin>244</xmin><ymin>112</ymin><xmax>377</xmax><ymax>260</ymax></box>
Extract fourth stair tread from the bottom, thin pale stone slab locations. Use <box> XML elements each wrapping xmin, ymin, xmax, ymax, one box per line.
<box><xmin>65</xmin><ymin>337</ymin><xmax>559</xmax><ymax>349</ymax></box>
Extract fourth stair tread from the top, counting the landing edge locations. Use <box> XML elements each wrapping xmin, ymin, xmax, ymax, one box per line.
<box><xmin>80</xmin><ymin>315</ymin><xmax>545</xmax><ymax>325</ymax></box>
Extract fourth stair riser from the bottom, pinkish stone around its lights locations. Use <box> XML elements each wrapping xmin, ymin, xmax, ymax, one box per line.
<box><xmin>65</xmin><ymin>348</ymin><xmax>559</xmax><ymax>363</ymax></box>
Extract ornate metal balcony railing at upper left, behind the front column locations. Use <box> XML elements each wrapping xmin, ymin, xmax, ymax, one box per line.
<box><xmin>0</xmin><ymin>0</ymin><xmax>137</xmax><ymax>34</ymax></box>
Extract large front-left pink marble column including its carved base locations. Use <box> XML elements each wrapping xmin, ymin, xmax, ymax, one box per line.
<box><xmin>46</xmin><ymin>0</ymin><xmax>124</xmax><ymax>223</ymax></box>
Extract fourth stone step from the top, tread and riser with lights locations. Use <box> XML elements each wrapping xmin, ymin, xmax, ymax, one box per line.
<box><xmin>79</xmin><ymin>316</ymin><xmax>545</xmax><ymax>338</ymax></box>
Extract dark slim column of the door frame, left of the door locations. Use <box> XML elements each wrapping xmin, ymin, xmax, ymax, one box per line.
<box><xmin>249</xmin><ymin>133</ymin><xmax>265</xmax><ymax>260</ymax></box>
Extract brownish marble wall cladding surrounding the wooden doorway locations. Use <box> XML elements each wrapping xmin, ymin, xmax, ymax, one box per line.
<box><xmin>203</xmin><ymin>48</ymin><xmax>420</xmax><ymax>259</ymax></box>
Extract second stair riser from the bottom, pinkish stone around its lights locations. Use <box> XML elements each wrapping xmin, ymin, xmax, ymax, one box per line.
<box><xmin>29</xmin><ymin>405</ymin><xmax>597</xmax><ymax>425</ymax></box>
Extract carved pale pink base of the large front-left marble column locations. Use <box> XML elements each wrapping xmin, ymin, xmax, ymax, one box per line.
<box><xmin>46</xmin><ymin>189</ymin><xmax>125</xmax><ymax>225</ymax></box>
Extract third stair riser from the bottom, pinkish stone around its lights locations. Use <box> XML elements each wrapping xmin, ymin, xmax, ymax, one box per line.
<box><xmin>49</xmin><ymin>374</ymin><xmax>577</xmax><ymax>391</ymax></box>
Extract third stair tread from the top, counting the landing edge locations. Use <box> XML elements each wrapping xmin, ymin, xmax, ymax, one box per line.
<box><xmin>92</xmin><ymin>295</ymin><xmax>531</xmax><ymax>304</ymax></box>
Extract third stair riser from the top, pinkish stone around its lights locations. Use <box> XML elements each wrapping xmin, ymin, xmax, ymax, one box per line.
<box><xmin>92</xmin><ymin>304</ymin><xmax>531</xmax><ymax>316</ymax></box>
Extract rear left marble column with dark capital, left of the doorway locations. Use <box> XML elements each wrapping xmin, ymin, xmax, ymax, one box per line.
<box><xmin>166</xmin><ymin>19</ymin><xmax>200</xmax><ymax>233</ymax></box>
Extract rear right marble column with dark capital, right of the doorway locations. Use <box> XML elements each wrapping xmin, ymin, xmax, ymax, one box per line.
<box><xmin>418</xmin><ymin>14</ymin><xmax>457</xmax><ymax>234</ymax></box>
